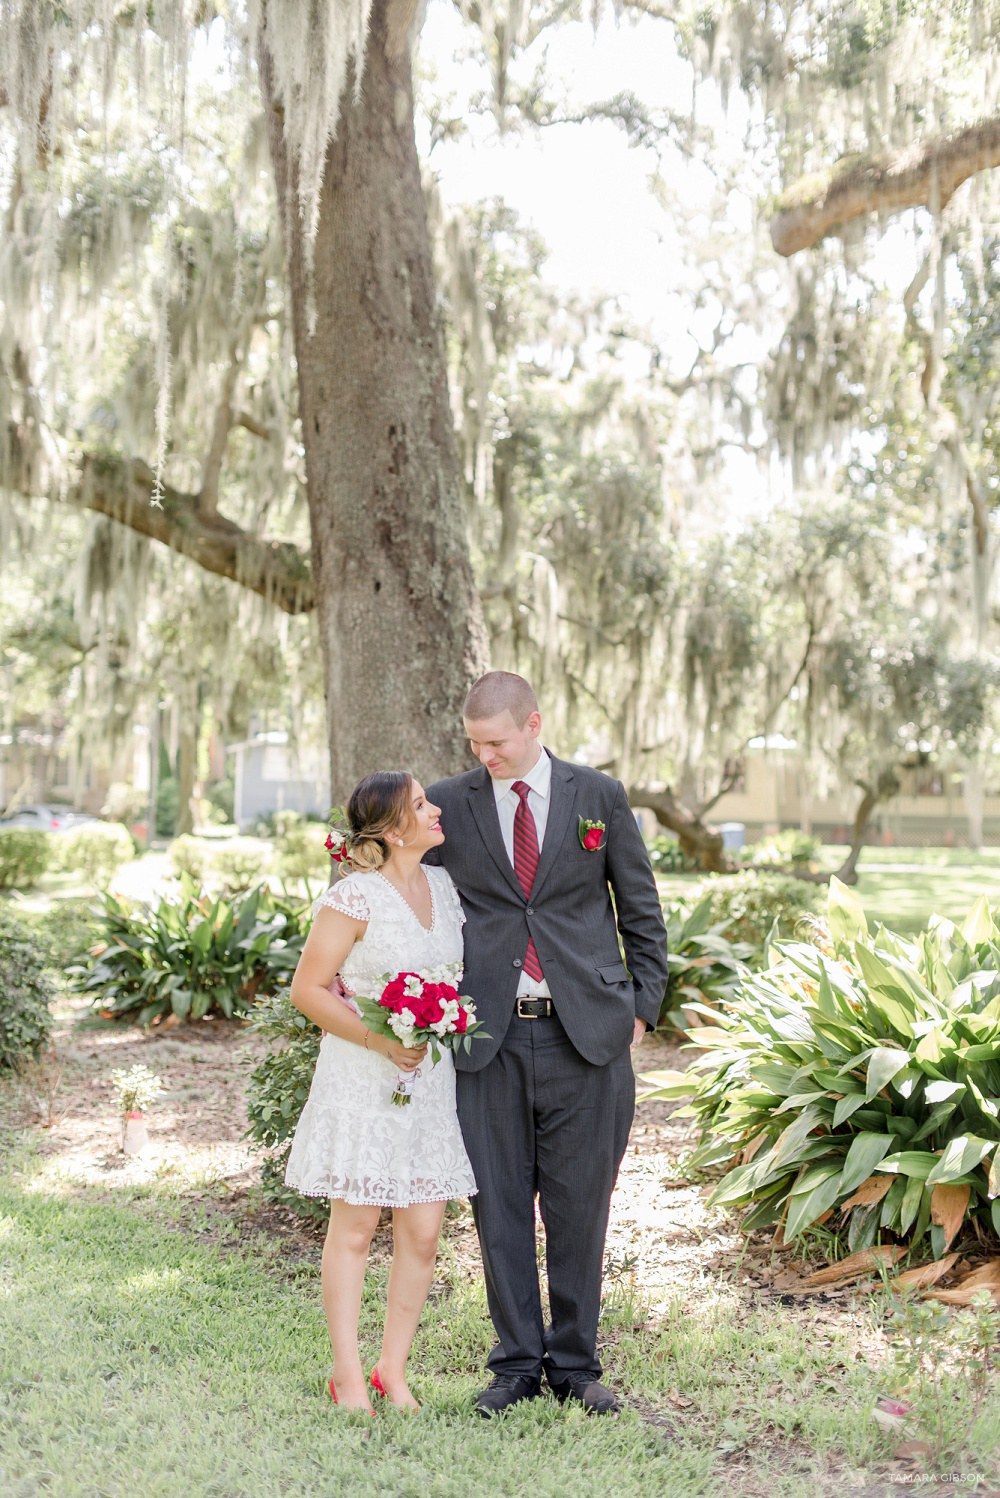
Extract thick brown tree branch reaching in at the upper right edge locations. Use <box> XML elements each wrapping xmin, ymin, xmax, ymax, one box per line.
<box><xmin>771</xmin><ymin>117</ymin><xmax>1000</xmax><ymax>256</ymax></box>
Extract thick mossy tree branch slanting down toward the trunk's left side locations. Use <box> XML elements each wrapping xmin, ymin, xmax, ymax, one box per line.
<box><xmin>0</xmin><ymin>422</ymin><xmax>314</xmax><ymax>614</ymax></box>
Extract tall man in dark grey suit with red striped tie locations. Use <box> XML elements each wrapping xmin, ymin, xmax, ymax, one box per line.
<box><xmin>427</xmin><ymin>671</ymin><xmax>666</xmax><ymax>1416</ymax></box>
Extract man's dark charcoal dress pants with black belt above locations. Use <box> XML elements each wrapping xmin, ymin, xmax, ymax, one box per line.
<box><xmin>457</xmin><ymin>1011</ymin><xmax>635</xmax><ymax>1384</ymax></box>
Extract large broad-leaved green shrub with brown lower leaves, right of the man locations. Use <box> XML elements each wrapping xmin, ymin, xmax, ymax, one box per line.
<box><xmin>651</xmin><ymin>879</ymin><xmax>1000</xmax><ymax>1257</ymax></box>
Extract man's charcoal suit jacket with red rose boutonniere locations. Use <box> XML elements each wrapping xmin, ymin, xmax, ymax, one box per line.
<box><xmin>427</xmin><ymin>755</ymin><xmax>668</xmax><ymax>1071</ymax></box>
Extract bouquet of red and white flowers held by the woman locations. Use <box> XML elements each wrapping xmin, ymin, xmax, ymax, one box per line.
<box><xmin>355</xmin><ymin>963</ymin><xmax>490</xmax><ymax>1107</ymax></box>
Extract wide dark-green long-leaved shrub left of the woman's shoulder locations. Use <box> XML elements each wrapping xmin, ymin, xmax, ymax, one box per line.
<box><xmin>72</xmin><ymin>875</ymin><xmax>307</xmax><ymax>1025</ymax></box>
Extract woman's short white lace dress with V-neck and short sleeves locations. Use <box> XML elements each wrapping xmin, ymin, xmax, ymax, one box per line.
<box><xmin>284</xmin><ymin>867</ymin><xmax>476</xmax><ymax>1207</ymax></box>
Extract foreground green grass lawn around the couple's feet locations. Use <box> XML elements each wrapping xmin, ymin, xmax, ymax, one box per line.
<box><xmin>0</xmin><ymin>1134</ymin><xmax>970</xmax><ymax>1498</ymax></box>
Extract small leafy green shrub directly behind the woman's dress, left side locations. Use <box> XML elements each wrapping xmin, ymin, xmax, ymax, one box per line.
<box><xmin>247</xmin><ymin>992</ymin><xmax>329</xmax><ymax>1222</ymax></box>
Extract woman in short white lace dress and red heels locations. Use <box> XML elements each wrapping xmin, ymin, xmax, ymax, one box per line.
<box><xmin>284</xmin><ymin>770</ymin><xmax>476</xmax><ymax>1414</ymax></box>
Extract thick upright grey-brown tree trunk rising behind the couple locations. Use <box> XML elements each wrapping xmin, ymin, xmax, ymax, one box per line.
<box><xmin>259</xmin><ymin>0</ymin><xmax>487</xmax><ymax>800</ymax></box>
